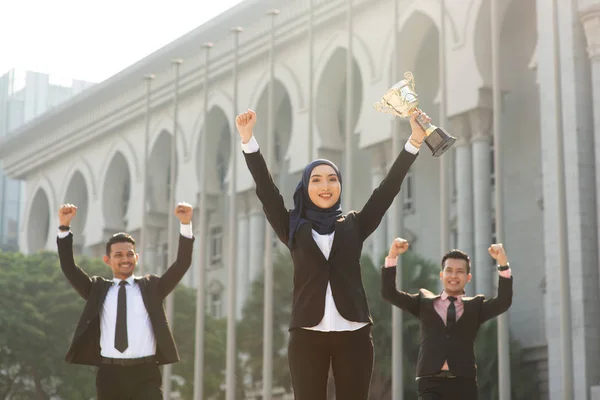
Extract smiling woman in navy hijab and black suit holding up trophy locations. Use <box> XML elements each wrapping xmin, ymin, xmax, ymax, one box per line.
<box><xmin>236</xmin><ymin>110</ymin><xmax>429</xmax><ymax>400</ymax></box>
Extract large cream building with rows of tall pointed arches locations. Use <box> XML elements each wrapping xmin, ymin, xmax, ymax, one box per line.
<box><xmin>0</xmin><ymin>0</ymin><xmax>600</xmax><ymax>399</ymax></box>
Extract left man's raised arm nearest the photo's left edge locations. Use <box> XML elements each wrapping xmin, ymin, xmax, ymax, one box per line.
<box><xmin>56</xmin><ymin>204</ymin><xmax>92</xmax><ymax>300</ymax></box>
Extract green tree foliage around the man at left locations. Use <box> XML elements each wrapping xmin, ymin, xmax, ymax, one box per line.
<box><xmin>0</xmin><ymin>248</ymin><xmax>226</xmax><ymax>400</ymax></box>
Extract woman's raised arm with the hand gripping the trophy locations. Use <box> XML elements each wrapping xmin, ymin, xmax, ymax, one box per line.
<box><xmin>356</xmin><ymin>111</ymin><xmax>431</xmax><ymax>240</ymax></box>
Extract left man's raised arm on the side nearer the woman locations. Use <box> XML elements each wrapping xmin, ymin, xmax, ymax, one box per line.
<box><xmin>158</xmin><ymin>203</ymin><xmax>194</xmax><ymax>298</ymax></box>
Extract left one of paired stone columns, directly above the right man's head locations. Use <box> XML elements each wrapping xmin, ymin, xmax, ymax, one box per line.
<box><xmin>450</xmin><ymin>114</ymin><xmax>477</xmax><ymax>292</ymax></box>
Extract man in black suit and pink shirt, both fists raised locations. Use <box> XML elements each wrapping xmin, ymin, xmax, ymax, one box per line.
<box><xmin>381</xmin><ymin>238</ymin><xmax>512</xmax><ymax>400</ymax></box>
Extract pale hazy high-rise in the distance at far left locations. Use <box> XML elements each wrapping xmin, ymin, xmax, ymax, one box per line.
<box><xmin>0</xmin><ymin>69</ymin><xmax>93</xmax><ymax>251</ymax></box>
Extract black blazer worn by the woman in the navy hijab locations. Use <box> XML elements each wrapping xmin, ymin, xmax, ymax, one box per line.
<box><xmin>244</xmin><ymin>150</ymin><xmax>417</xmax><ymax>329</ymax></box>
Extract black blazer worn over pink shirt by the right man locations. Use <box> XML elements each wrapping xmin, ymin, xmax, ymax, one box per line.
<box><xmin>381</xmin><ymin>267</ymin><xmax>512</xmax><ymax>379</ymax></box>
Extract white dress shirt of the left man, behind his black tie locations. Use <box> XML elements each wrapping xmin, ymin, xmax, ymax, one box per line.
<box><xmin>58</xmin><ymin>222</ymin><xmax>193</xmax><ymax>358</ymax></box>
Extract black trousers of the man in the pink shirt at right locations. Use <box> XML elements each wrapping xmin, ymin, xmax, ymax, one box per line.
<box><xmin>417</xmin><ymin>378</ymin><xmax>478</xmax><ymax>400</ymax></box>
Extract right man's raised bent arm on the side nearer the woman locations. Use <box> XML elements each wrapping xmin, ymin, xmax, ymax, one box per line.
<box><xmin>381</xmin><ymin>238</ymin><xmax>420</xmax><ymax>318</ymax></box>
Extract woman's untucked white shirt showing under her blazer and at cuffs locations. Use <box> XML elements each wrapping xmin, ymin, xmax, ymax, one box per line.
<box><xmin>242</xmin><ymin>136</ymin><xmax>419</xmax><ymax>332</ymax></box>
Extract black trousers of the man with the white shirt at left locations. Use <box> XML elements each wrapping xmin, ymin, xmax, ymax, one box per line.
<box><xmin>96</xmin><ymin>364</ymin><xmax>162</xmax><ymax>400</ymax></box>
